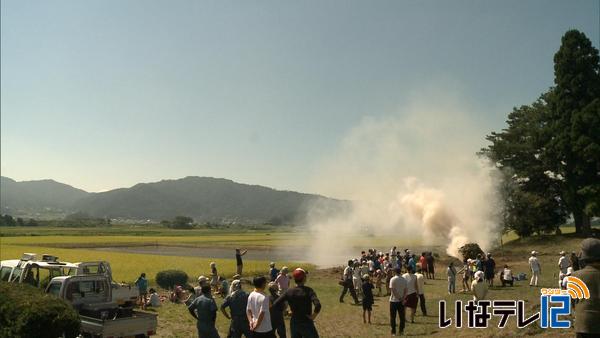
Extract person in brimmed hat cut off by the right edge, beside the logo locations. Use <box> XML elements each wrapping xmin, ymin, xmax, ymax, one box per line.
<box><xmin>572</xmin><ymin>238</ymin><xmax>600</xmax><ymax>337</ymax></box>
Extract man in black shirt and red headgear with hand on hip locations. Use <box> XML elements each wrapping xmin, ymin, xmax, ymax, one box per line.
<box><xmin>273</xmin><ymin>268</ymin><xmax>321</xmax><ymax>338</ymax></box>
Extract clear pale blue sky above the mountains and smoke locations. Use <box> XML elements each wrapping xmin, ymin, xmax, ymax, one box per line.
<box><xmin>1</xmin><ymin>0</ymin><xmax>600</xmax><ymax>192</ymax></box>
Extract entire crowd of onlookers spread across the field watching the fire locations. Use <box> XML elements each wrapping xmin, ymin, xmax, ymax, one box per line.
<box><xmin>135</xmin><ymin>239</ymin><xmax>600</xmax><ymax>338</ymax></box>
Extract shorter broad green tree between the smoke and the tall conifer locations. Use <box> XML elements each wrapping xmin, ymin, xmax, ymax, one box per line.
<box><xmin>482</xmin><ymin>95</ymin><xmax>566</xmax><ymax>236</ymax></box>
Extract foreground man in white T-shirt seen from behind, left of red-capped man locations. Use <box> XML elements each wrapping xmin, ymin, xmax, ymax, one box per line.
<box><xmin>246</xmin><ymin>276</ymin><xmax>275</xmax><ymax>338</ymax></box>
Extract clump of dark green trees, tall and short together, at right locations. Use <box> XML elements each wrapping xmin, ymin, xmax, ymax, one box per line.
<box><xmin>481</xmin><ymin>30</ymin><xmax>600</xmax><ymax>236</ymax></box>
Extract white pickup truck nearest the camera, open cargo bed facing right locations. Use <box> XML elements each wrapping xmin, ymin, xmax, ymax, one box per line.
<box><xmin>46</xmin><ymin>275</ymin><xmax>157</xmax><ymax>338</ymax></box>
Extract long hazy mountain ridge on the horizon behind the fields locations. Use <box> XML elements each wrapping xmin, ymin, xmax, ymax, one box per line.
<box><xmin>0</xmin><ymin>177</ymin><xmax>349</xmax><ymax>225</ymax></box>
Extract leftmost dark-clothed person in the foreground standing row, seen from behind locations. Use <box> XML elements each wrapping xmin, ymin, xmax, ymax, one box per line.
<box><xmin>188</xmin><ymin>285</ymin><xmax>219</xmax><ymax>338</ymax></box>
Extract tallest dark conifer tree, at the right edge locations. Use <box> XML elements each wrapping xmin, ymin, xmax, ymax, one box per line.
<box><xmin>541</xmin><ymin>30</ymin><xmax>600</xmax><ymax>235</ymax></box>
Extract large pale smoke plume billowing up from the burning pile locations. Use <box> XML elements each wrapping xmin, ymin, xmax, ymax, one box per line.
<box><xmin>308</xmin><ymin>90</ymin><xmax>499</xmax><ymax>266</ymax></box>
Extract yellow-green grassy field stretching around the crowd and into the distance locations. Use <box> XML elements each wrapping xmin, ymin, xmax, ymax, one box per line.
<box><xmin>0</xmin><ymin>228</ymin><xmax>592</xmax><ymax>337</ymax></box>
